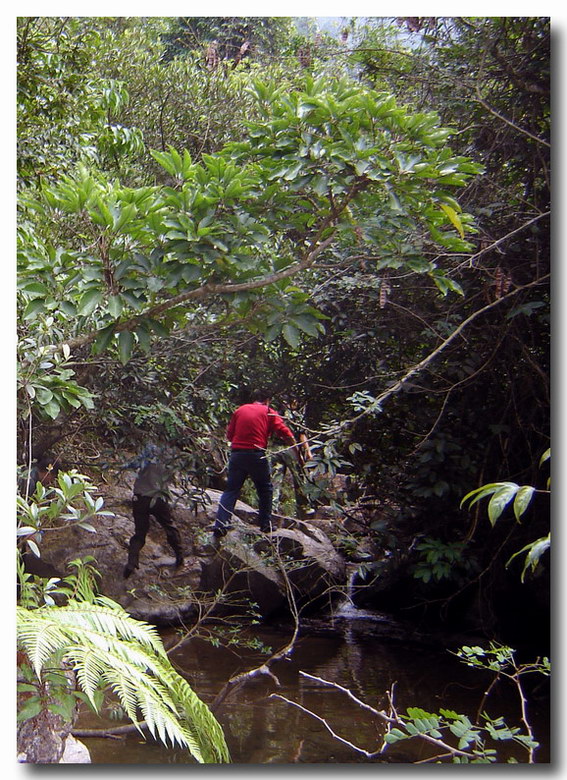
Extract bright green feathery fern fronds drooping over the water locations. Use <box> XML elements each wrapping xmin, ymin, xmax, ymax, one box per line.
<box><xmin>17</xmin><ymin>596</ymin><xmax>230</xmax><ymax>763</ymax></box>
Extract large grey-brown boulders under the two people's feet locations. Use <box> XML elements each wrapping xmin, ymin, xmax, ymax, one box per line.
<box><xmin>35</xmin><ymin>474</ymin><xmax>344</xmax><ymax>625</ymax></box>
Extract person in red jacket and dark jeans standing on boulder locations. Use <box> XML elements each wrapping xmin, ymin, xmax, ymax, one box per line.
<box><xmin>213</xmin><ymin>390</ymin><xmax>296</xmax><ymax>537</ymax></box>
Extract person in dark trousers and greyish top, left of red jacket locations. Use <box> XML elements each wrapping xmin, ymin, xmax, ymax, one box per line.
<box><xmin>122</xmin><ymin>444</ymin><xmax>184</xmax><ymax>578</ymax></box>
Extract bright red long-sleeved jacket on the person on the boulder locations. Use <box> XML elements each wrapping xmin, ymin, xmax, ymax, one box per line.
<box><xmin>226</xmin><ymin>401</ymin><xmax>295</xmax><ymax>450</ymax></box>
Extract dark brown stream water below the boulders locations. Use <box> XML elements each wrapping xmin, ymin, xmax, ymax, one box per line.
<box><xmin>78</xmin><ymin>613</ymin><xmax>549</xmax><ymax>764</ymax></box>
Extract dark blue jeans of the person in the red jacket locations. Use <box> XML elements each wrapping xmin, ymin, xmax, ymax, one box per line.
<box><xmin>215</xmin><ymin>450</ymin><xmax>273</xmax><ymax>530</ymax></box>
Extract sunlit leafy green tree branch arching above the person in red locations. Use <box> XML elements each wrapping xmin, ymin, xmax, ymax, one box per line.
<box><xmin>19</xmin><ymin>79</ymin><xmax>479</xmax><ymax>374</ymax></box>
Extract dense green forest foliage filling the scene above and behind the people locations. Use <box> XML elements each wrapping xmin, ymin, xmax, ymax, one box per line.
<box><xmin>18</xmin><ymin>17</ymin><xmax>550</xmax><ymax>760</ymax></box>
